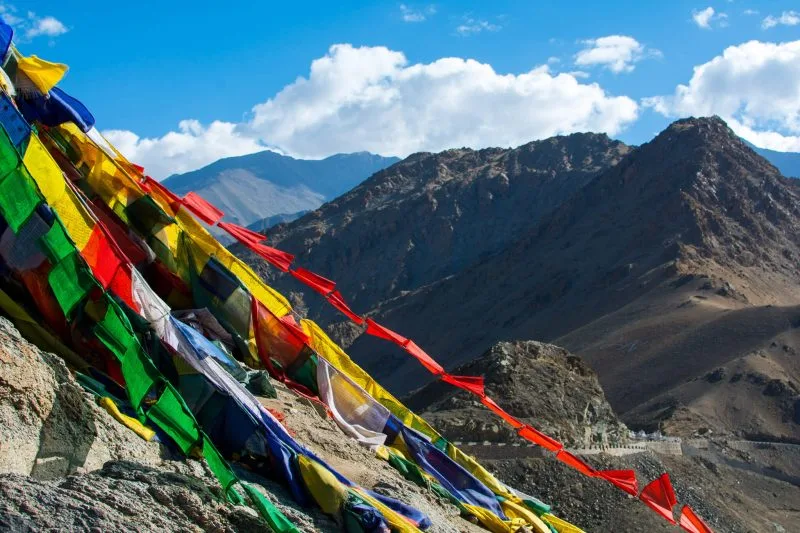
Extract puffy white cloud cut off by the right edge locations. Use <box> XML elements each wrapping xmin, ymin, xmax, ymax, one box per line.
<box><xmin>642</xmin><ymin>41</ymin><xmax>800</xmax><ymax>151</ymax></box>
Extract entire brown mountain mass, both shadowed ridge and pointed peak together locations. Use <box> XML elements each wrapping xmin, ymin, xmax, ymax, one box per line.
<box><xmin>241</xmin><ymin>118</ymin><xmax>800</xmax><ymax>440</ymax></box>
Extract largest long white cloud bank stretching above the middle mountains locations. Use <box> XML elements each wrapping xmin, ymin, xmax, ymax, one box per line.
<box><xmin>107</xmin><ymin>44</ymin><xmax>638</xmax><ymax>178</ymax></box>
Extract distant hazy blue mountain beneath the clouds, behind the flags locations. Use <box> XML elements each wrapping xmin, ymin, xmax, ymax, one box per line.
<box><xmin>164</xmin><ymin>150</ymin><xmax>398</xmax><ymax>226</ymax></box>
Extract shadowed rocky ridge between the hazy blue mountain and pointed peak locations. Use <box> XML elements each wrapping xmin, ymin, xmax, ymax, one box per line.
<box><xmin>237</xmin><ymin>134</ymin><xmax>630</xmax><ymax>321</ymax></box>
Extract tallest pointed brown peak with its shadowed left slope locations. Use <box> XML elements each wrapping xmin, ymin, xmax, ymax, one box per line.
<box><xmin>351</xmin><ymin>118</ymin><xmax>800</xmax><ymax>440</ymax></box>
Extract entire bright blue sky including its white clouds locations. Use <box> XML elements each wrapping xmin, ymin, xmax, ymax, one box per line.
<box><xmin>10</xmin><ymin>0</ymin><xmax>800</xmax><ymax>177</ymax></box>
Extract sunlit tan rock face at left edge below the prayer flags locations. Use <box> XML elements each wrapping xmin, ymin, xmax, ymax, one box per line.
<box><xmin>0</xmin><ymin>317</ymin><xmax>162</xmax><ymax>479</ymax></box>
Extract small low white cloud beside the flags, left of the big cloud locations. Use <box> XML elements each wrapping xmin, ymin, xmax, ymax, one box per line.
<box><xmin>103</xmin><ymin>120</ymin><xmax>267</xmax><ymax>179</ymax></box>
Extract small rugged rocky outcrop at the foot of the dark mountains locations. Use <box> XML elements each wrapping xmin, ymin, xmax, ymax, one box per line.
<box><xmin>407</xmin><ymin>341</ymin><xmax>628</xmax><ymax>448</ymax></box>
